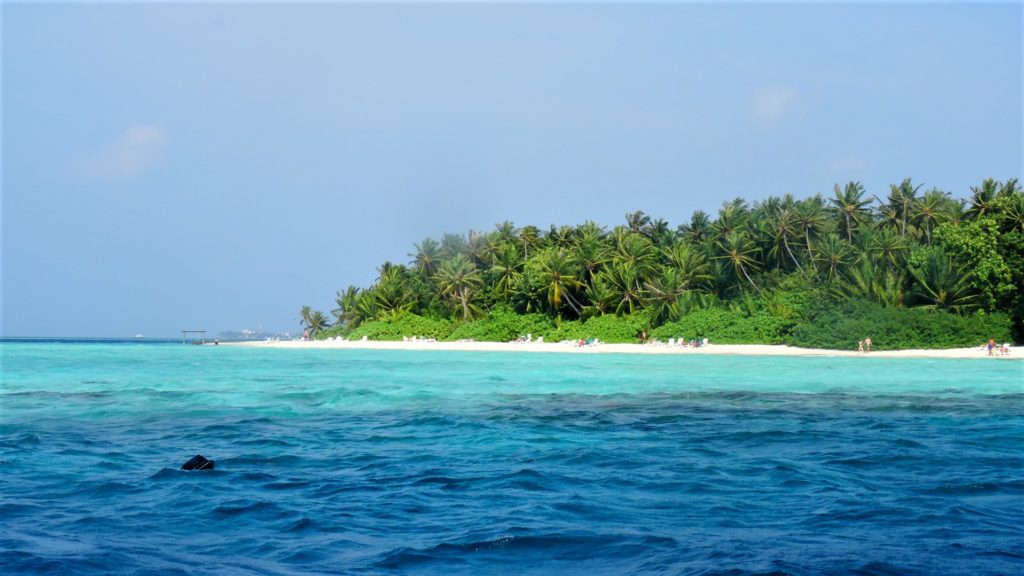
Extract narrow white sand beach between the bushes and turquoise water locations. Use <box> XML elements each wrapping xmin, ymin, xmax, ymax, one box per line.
<box><xmin>221</xmin><ymin>340</ymin><xmax>1024</xmax><ymax>360</ymax></box>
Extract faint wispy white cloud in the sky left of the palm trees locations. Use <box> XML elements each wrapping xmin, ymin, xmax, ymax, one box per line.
<box><xmin>76</xmin><ymin>124</ymin><xmax>167</xmax><ymax>180</ymax></box>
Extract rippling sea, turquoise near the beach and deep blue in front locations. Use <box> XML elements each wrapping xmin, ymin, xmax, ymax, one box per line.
<box><xmin>0</xmin><ymin>341</ymin><xmax>1024</xmax><ymax>575</ymax></box>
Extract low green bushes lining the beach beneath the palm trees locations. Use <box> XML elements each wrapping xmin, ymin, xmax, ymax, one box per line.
<box><xmin>317</xmin><ymin>300</ymin><xmax>1011</xmax><ymax>351</ymax></box>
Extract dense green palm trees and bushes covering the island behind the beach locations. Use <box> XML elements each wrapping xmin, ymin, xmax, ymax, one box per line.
<box><xmin>302</xmin><ymin>179</ymin><xmax>1024</xmax><ymax>349</ymax></box>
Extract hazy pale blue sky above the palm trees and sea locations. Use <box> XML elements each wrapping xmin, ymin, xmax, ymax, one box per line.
<box><xmin>0</xmin><ymin>2</ymin><xmax>1024</xmax><ymax>336</ymax></box>
